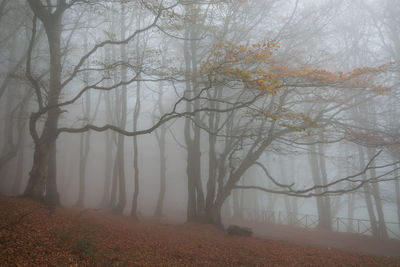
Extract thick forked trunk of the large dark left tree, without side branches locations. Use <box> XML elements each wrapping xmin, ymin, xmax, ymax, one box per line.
<box><xmin>24</xmin><ymin>0</ymin><xmax>64</xmax><ymax>204</ymax></box>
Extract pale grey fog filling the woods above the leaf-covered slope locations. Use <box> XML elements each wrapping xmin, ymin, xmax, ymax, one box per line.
<box><xmin>0</xmin><ymin>0</ymin><xmax>400</xmax><ymax>243</ymax></box>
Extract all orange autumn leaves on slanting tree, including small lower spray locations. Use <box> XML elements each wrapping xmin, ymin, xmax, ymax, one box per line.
<box><xmin>202</xmin><ymin>40</ymin><xmax>390</xmax><ymax>131</ymax></box>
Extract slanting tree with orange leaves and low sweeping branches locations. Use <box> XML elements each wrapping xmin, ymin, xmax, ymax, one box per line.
<box><xmin>195</xmin><ymin>39</ymin><xmax>396</xmax><ymax>225</ymax></box>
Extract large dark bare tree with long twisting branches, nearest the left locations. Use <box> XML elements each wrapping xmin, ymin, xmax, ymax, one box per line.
<box><xmin>24</xmin><ymin>0</ymin><xmax>182</xmax><ymax>205</ymax></box>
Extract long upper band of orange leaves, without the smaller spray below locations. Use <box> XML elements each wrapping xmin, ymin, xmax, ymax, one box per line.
<box><xmin>202</xmin><ymin>41</ymin><xmax>390</xmax><ymax>94</ymax></box>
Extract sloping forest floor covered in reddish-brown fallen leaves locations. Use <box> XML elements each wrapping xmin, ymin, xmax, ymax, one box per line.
<box><xmin>0</xmin><ymin>196</ymin><xmax>400</xmax><ymax>266</ymax></box>
